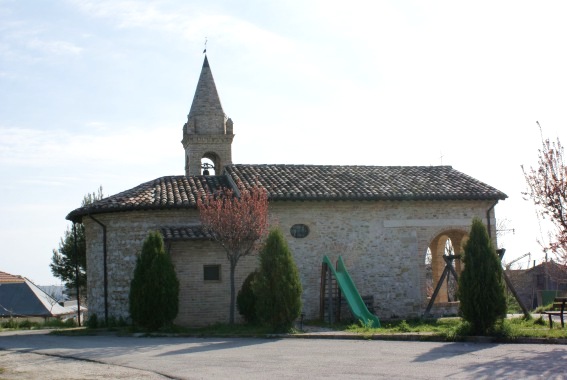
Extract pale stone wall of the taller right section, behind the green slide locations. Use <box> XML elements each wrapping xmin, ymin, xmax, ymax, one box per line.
<box><xmin>270</xmin><ymin>201</ymin><xmax>495</xmax><ymax>319</ymax></box>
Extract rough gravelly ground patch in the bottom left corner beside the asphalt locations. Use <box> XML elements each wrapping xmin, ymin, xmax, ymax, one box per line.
<box><xmin>0</xmin><ymin>351</ymin><xmax>171</xmax><ymax>380</ymax></box>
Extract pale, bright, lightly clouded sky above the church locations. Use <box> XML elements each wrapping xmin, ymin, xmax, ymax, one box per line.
<box><xmin>0</xmin><ymin>0</ymin><xmax>567</xmax><ymax>285</ymax></box>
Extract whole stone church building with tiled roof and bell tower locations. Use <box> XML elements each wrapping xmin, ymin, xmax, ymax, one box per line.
<box><xmin>67</xmin><ymin>56</ymin><xmax>506</xmax><ymax>326</ymax></box>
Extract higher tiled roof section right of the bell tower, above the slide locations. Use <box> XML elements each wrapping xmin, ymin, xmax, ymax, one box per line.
<box><xmin>226</xmin><ymin>165</ymin><xmax>506</xmax><ymax>200</ymax></box>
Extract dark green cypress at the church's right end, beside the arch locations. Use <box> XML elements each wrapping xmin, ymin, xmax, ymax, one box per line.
<box><xmin>458</xmin><ymin>218</ymin><xmax>506</xmax><ymax>335</ymax></box>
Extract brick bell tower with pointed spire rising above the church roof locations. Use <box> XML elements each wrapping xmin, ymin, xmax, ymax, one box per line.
<box><xmin>181</xmin><ymin>55</ymin><xmax>234</xmax><ymax>176</ymax></box>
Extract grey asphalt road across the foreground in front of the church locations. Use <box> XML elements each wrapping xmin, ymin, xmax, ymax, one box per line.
<box><xmin>0</xmin><ymin>331</ymin><xmax>567</xmax><ymax>379</ymax></box>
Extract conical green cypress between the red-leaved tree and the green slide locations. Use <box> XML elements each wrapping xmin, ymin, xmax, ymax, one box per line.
<box><xmin>254</xmin><ymin>228</ymin><xmax>302</xmax><ymax>331</ymax></box>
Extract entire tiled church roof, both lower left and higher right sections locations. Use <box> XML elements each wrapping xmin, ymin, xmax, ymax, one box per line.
<box><xmin>67</xmin><ymin>165</ymin><xmax>507</xmax><ymax>221</ymax></box>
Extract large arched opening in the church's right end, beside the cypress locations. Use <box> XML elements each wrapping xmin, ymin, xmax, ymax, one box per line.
<box><xmin>425</xmin><ymin>230</ymin><xmax>468</xmax><ymax>304</ymax></box>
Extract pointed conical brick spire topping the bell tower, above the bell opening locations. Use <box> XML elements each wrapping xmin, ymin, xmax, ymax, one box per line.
<box><xmin>187</xmin><ymin>55</ymin><xmax>226</xmax><ymax>134</ymax></box>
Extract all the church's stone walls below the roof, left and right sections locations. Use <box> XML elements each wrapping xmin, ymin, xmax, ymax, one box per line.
<box><xmin>83</xmin><ymin>197</ymin><xmax>495</xmax><ymax>325</ymax></box>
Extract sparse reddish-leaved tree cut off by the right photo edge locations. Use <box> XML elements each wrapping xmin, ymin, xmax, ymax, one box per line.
<box><xmin>522</xmin><ymin>123</ymin><xmax>567</xmax><ymax>264</ymax></box>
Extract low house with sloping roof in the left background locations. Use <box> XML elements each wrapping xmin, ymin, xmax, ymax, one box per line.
<box><xmin>0</xmin><ymin>272</ymin><xmax>83</xmax><ymax>322</ymax></box>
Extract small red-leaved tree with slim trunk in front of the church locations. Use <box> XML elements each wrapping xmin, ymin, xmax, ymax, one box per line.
<box><xmin>197</xmin><ymin>186</ymin><xmax>268</xmax><ymax>323</ymax></box>
